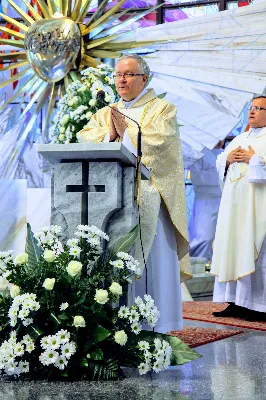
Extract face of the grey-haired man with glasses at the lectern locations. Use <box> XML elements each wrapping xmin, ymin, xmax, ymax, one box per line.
<box><xmin>115</xmin><ymin>58</ymin><xmax>148</xmax><ymax>101</ymax></box>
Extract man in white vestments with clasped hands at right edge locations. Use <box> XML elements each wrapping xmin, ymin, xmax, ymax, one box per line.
<box><xmin>211</xmin><ymin>96</ymin><xmax>266</xmax><ymax>320</ymax></box>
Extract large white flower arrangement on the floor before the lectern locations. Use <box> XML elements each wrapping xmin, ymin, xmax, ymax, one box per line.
<box><xmin>0</xmin><ymin>225</ymin><xmax>200</xmax><ymax>380</ymax></box>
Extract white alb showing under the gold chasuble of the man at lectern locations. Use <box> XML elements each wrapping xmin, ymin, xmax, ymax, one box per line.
<box><xmin>104</xmin><ymin>91</ymin><xmax>183</xmax><ymax>333</ymax></box>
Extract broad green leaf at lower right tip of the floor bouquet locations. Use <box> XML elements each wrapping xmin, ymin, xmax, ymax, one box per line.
<box><xmin>166</xmin><ymin>335</ymin><xmax>202</xmax><ymax>365</ymax></box>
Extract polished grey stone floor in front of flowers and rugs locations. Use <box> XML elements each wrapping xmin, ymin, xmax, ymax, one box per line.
<box><xmin>0</xmin><ymin>320</ymin><xmax>266</xmax><ymax>400</ymax></box>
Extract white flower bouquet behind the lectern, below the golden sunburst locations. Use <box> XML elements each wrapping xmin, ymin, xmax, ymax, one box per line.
<box><xmin>49</xmin><ymin>64</ymin><xmax>118</xmax><ymax>144</ymax></box>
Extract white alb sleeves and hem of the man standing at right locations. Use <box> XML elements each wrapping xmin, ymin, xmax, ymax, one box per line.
<box><xmin>213</xmin><ymin>128</ymin><xmax>266</xmax><ymax>312</ymax></box>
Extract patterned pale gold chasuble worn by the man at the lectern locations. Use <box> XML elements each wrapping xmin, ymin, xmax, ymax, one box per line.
<box><xmin>78</xmin><ymin>89</ymin><xmax>191</xmax><ymax>281</ymax></box>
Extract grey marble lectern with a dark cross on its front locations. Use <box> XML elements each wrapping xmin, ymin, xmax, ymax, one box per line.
<box><xmin>38</xmin><ymin>143</ymin><xmax>150</xmax><ymax>244</ymax></box>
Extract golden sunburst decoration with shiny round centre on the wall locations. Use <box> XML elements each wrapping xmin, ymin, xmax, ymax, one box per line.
<box><xmin>0</xmin><ymin>0</ymin><xmax>158</xmax><ymax>140</ymax></box>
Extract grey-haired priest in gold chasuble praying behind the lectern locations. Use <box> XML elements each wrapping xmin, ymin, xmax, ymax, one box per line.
<box><xmin>78</xmin><ymin>54</ymin><xmax>190</xmax><ymax>333</ymax></box>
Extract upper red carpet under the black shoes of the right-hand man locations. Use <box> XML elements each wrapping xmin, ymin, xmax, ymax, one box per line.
<box><xmin>183</xmin><ymin>301</ymin><xmax>266</xmax><ymax>331</ymax></box>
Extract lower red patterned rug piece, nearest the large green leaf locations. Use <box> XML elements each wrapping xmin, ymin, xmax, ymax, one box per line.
<box><xmin>169</xmin><ymin>326</ymin><xmax>243</xmax><ymax>347</ymax></box>
